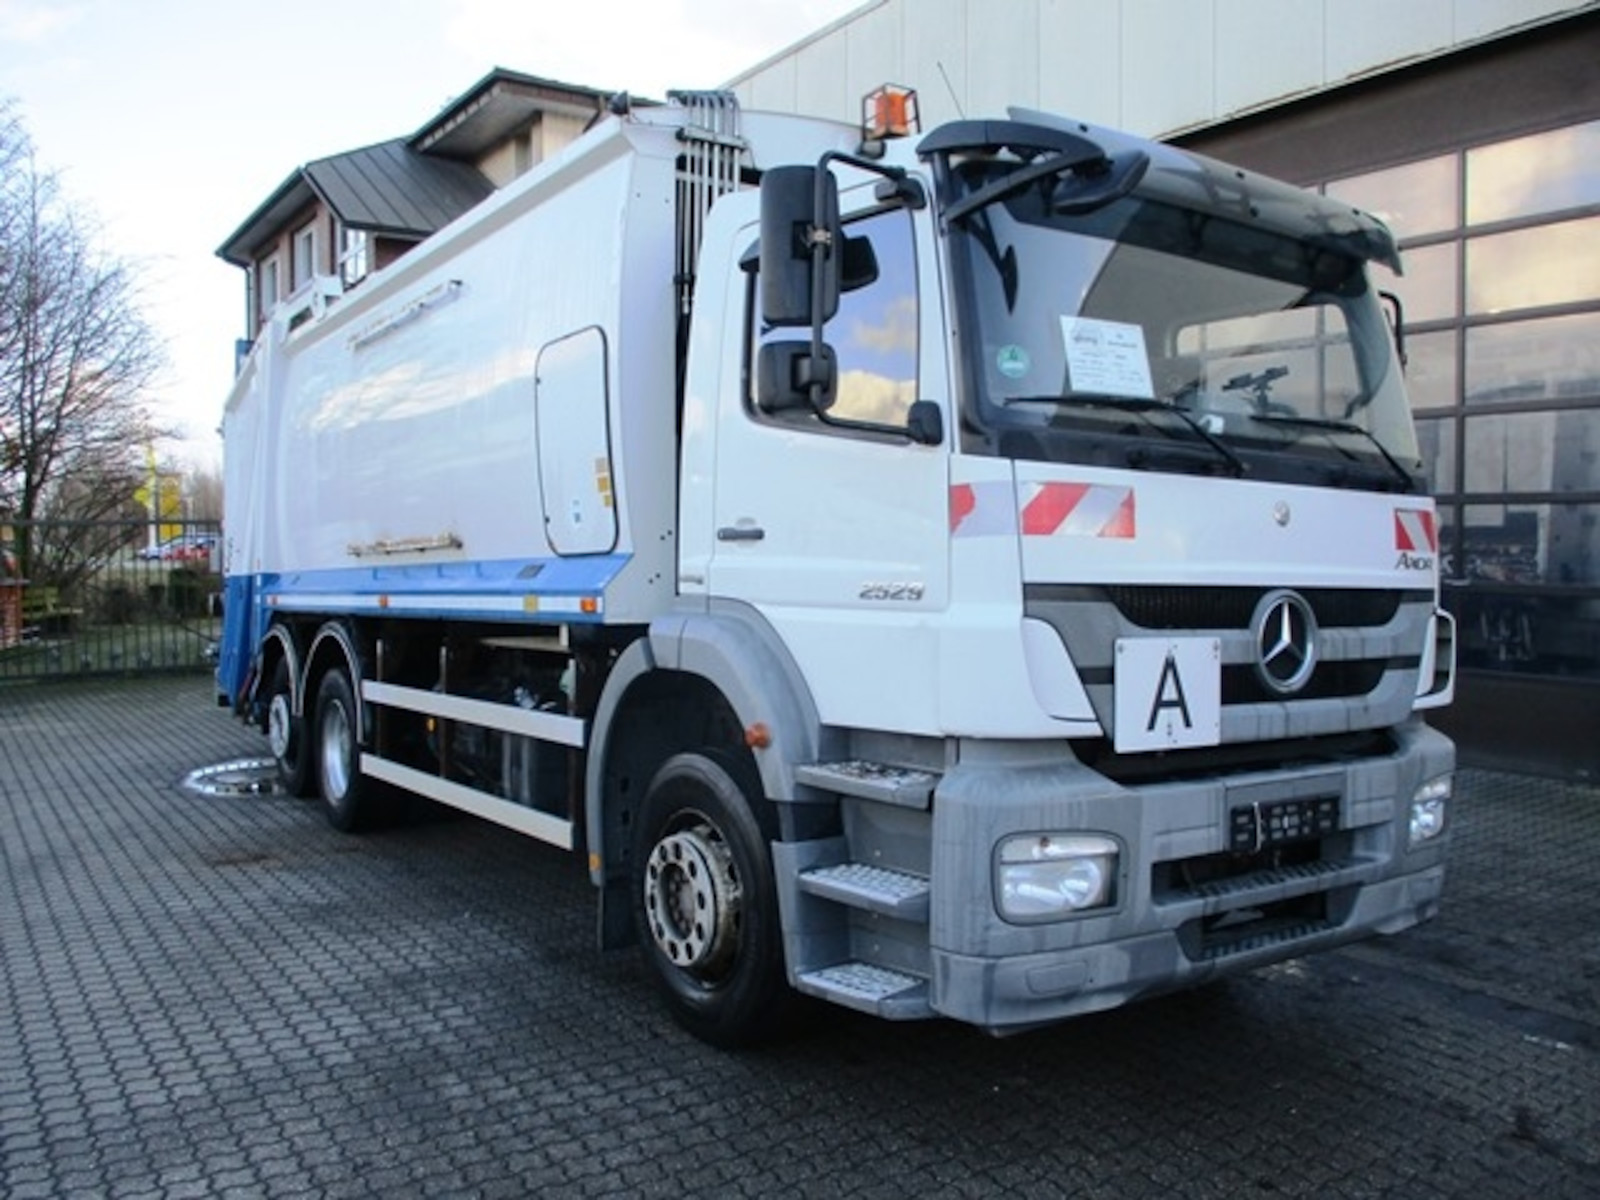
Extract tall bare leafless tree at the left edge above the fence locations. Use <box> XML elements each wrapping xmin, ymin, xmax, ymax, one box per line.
<box><xmin>0</xmin><ymin>104</ymin><xmax>163</xmax><ymax>574</ymax></box>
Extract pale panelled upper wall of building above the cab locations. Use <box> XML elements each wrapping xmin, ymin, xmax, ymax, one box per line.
<box><xmin>730</xmin><ymin>0</ymin><xmax>1595</xmax><ymax>136</ymax></box>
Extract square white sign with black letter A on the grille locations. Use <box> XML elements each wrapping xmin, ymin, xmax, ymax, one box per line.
<box><xmin>1112</xmin><ymin>637</ymin><xmax>1222</xmax><ymax>752</ymax></box>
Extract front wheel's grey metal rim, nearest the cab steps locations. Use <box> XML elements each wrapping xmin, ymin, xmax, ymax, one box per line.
<box><xmin>645</xmin><ymin>814</ymin><xmax>744</xmax><ymax>981</ymax></box>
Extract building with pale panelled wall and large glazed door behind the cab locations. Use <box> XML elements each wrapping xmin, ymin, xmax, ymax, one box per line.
<box><xmin>731</xmin><ymin>0</ymin><xmax>1600</xmax><ymax>778</ymax></box>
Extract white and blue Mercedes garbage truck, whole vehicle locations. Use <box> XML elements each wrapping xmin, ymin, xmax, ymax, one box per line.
<box><xmin>218</xmin><ymin>88</ymin><xmax>1454</xmax><ymax>1046</ymax></box>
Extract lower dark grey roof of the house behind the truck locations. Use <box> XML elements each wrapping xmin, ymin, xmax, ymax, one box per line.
<box><xmin>216</xmin><ymin>138</ymin><xmax>494</xmax><ymax>267</ymax></box>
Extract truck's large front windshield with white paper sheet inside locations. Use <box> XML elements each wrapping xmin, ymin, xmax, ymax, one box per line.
<box><xmin>950</xmin><ymin>160</ymin><xmax>1421</xmax><ymax>490</ymax></box>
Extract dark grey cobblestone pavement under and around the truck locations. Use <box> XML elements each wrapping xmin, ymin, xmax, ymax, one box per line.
<box><xmin>0</xmin><ymin>678</ymin><xmax>1600</xmax><ymax>1200</ymax></box>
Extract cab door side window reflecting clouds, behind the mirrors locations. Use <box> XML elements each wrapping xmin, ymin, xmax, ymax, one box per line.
<box><xmin>746</xmin><ymin>208</ymin><xmax>917</xmax><ymax>430</ymax></box>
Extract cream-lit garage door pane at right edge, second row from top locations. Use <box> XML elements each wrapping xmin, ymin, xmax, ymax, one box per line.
<box><xmin>1467</xmin><ymin>218</ymin><xmax>1600</xmax><ymax>312</ymax></box>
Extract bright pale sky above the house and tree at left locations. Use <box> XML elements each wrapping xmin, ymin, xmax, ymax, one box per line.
<box><xmin>0</xmin><ymin>0</ymin><xmax>861</xmax><ymax>466</ymax></box>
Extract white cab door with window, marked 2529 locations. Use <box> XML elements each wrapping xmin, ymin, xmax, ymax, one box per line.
<box><xmin>707</xmin><ymin>189</ymin><xmax>949</xmax><ymax>722</ymax></box>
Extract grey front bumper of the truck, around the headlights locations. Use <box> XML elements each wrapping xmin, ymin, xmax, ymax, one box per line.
<box><xmin>928</xmin><ymin>722</ymin><xmax>1454</xmax><ymax>1030</ymax></box>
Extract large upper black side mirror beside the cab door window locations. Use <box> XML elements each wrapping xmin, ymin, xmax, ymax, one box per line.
<box><xmin>762</xmin><ymin>166</ymin><xmax>843</xmax><ymax>328</ymax></box>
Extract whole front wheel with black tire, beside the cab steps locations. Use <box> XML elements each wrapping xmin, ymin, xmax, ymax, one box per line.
<box><xmin>632</xmin><ymin>754</ymin><xmax>794</xmax><ymax>1048</ymax></box>
